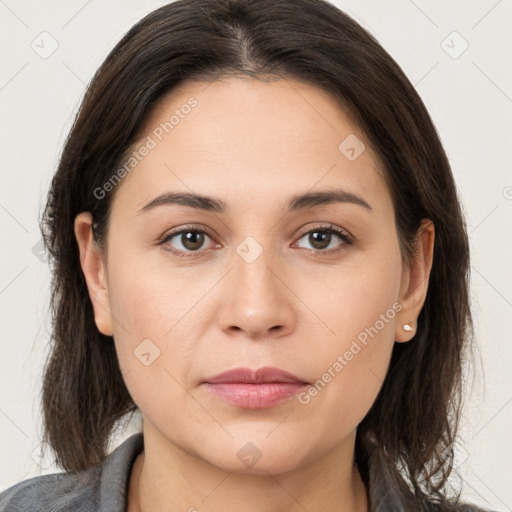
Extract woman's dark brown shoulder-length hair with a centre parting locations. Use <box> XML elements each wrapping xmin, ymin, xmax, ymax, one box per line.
<box><xmin>41</xmin><ymin>0</ymin><xmax>480</xmax><ymax>512</ymax></box>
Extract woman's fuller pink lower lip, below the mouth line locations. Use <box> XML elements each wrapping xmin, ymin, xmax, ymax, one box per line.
<box><xmin>204</xmin><ymin>382</ymin><xmax>309</xmax><ymax>409</ymax></box>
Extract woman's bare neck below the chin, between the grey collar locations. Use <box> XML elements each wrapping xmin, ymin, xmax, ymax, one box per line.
<box><xmin>127</xmin><ymin>426</ymin><xmax>369</xmax><ymax>512</ymax></box>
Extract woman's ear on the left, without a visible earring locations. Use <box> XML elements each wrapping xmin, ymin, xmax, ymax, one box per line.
<box><xmin>75</xmin><ymin>212</ymin><xmax>113</xmax><ymax>336</ymax></box>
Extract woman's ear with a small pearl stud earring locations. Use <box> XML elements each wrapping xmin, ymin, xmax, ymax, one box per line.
<box><xmin>395</xmin><ymin>219</ymin><xmax>435</xmax><ymax>343</ymax></box>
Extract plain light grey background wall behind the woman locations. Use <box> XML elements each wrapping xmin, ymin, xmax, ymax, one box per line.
<box><xmin>0</xmin><ymin>0</ymin><xmax>512</xmax><ymax>511</ymax></box>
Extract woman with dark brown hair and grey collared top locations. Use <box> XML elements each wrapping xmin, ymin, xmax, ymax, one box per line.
<box><xmin>0</xmin><ymin>0</ymin><xmax>498</xmax><ymax>512</ymax></box>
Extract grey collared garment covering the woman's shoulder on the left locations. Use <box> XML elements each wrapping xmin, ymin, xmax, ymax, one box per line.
<box><xmin>0</xmin><ymin>433</ymin><xmax>143</xmax><ymax>512</ymax></box>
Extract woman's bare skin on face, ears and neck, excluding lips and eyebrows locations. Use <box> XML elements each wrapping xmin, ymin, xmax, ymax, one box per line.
<box><xmin>75</xmin><ymin>78</ymin><xmax>434</xmax><ymax>512</ymax></box>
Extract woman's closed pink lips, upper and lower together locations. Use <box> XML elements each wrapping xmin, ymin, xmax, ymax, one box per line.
<box><xmin>202</xmin><ymin>366</ymin><xmax>309</xmax><ymax>409</ymax></box>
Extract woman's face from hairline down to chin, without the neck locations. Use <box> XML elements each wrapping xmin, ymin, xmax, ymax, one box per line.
<box><xmin>74</xmin><ymin>78</ymin><xmax>430</xmax><ymax>473</ymax></box>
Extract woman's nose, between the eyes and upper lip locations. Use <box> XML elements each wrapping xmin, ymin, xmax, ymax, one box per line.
<box><xmin>218</xmin><ymin>240</ymin><xmax>300</xmax><ymax>339</ymax></box>
